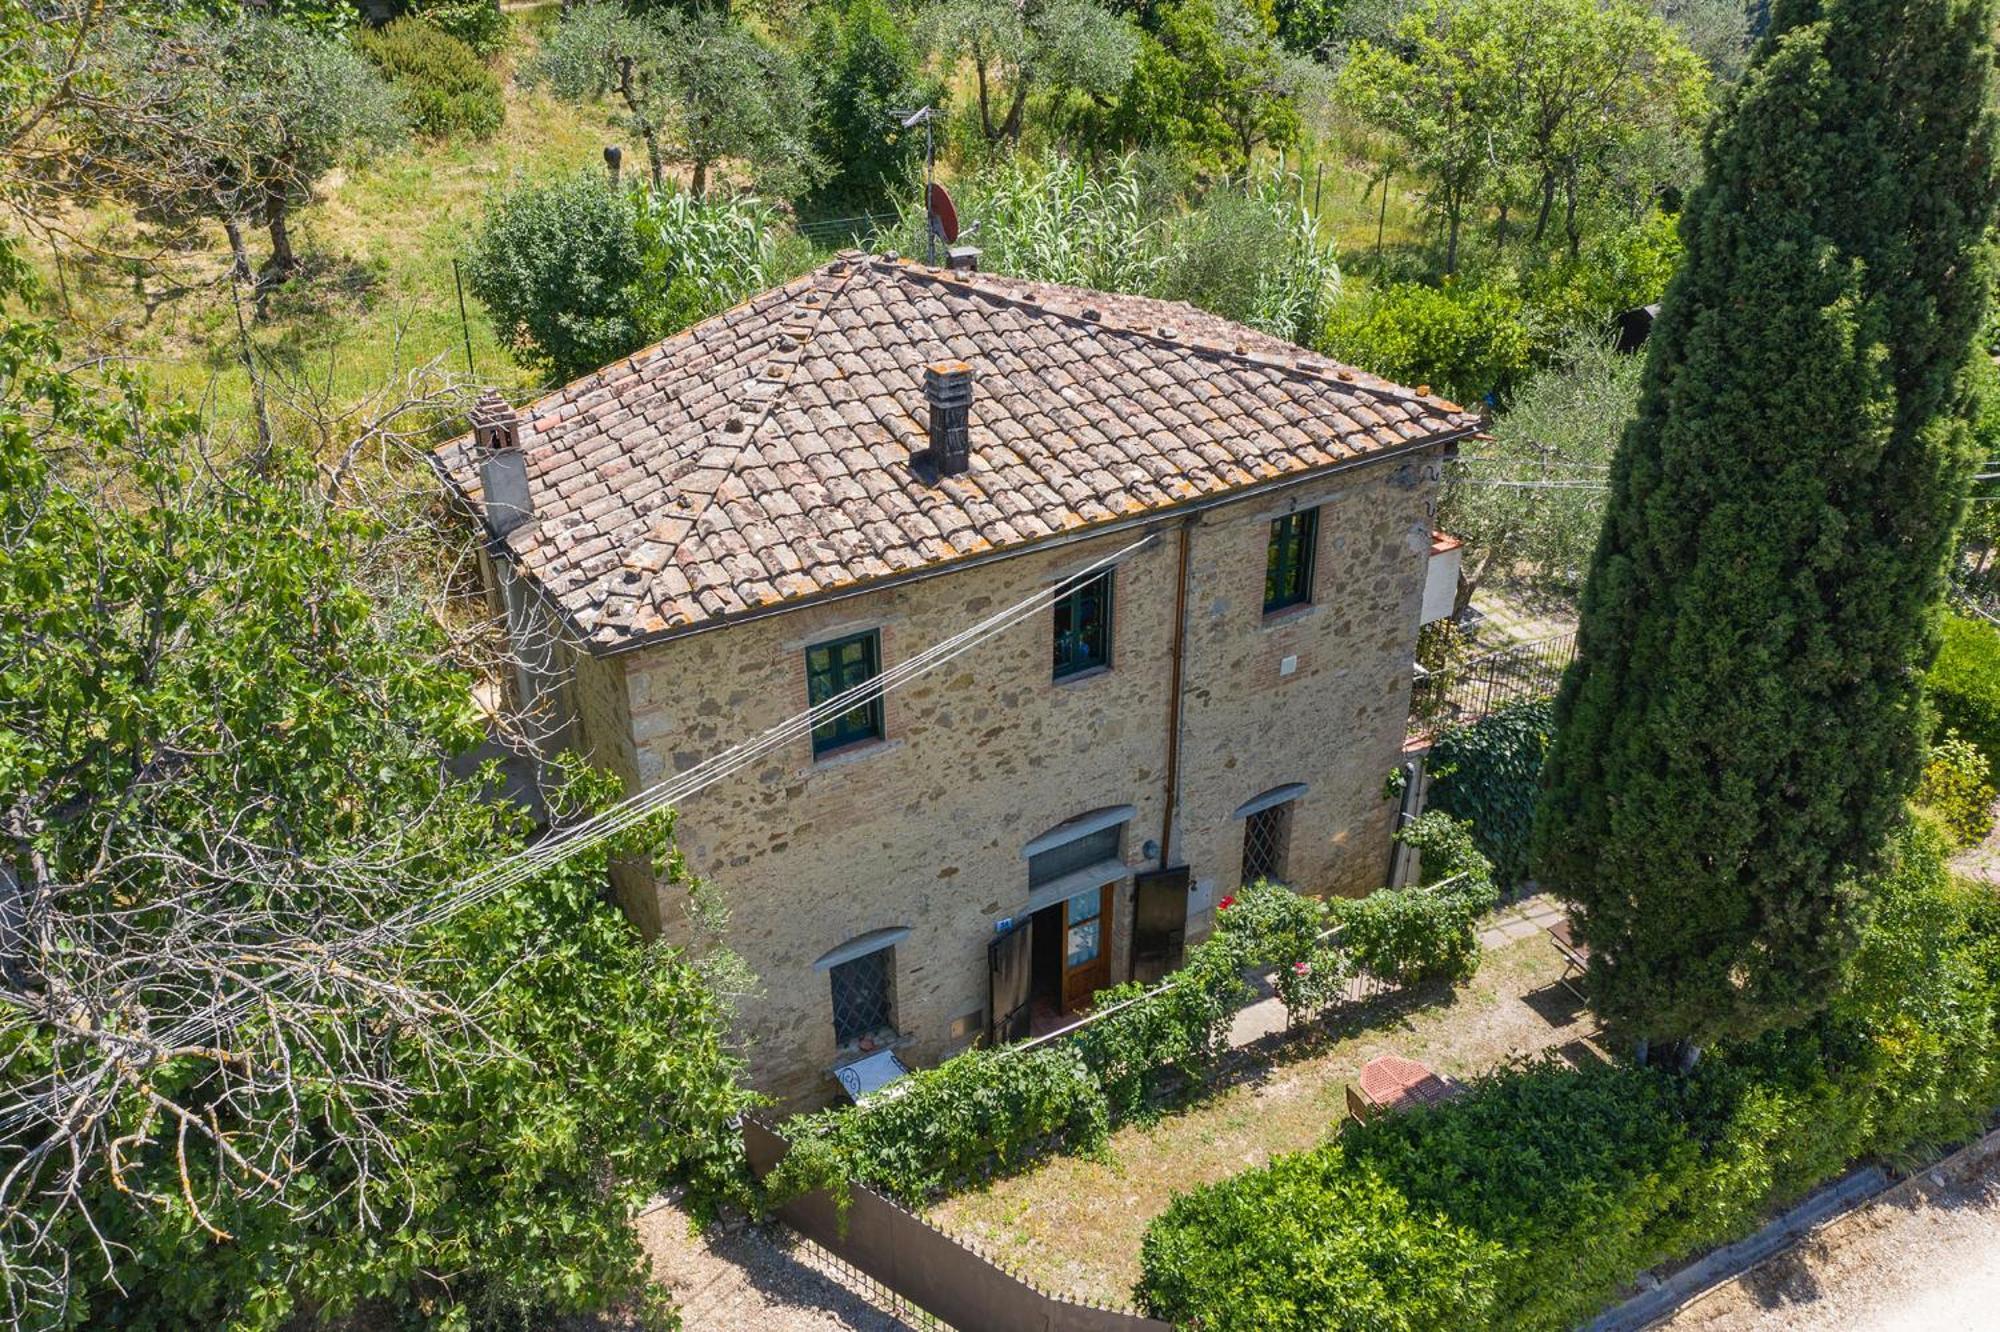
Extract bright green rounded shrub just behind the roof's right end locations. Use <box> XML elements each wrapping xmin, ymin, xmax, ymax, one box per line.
<box><xmin>1322</xmin><ymin>280</ymin><xmax>1532</xmax><ymax>404</ymax></box>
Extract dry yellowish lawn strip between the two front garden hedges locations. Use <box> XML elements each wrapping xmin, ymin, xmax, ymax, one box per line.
<box><xmin>928</xmin><ymin>938</ymin><xmax>1598</xmax><ymax>1302</ymax></box>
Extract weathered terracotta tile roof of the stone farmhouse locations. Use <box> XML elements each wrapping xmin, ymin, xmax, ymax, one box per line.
<box><xmin>438</xmin><ymin>254</ymin><xmax>1476</xmax><ymax>650</ymax></box>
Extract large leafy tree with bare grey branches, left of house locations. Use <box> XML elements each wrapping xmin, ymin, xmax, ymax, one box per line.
<box><xmin>0</xmin><ymin>274</ymin><xmax>746</xmax><ymax>1332</ymax></box>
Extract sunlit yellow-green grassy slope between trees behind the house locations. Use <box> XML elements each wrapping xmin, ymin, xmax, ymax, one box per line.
<box><xmin>19</xmin><ymin>4</ymin><xmax>1420</xmax><ymax>422</ymax></box>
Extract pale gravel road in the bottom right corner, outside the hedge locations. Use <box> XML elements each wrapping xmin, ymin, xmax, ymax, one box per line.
<box><xmin>1664</xmin><ymin>1156</ymin><xmax>2000</xmax><ymax>1332</ymax></box>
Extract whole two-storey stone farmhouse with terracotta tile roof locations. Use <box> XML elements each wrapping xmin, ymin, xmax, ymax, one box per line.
<box><xmin>438</xmin><ymin>252</ymin><xmax>1478</xmax><ymax>1102</ymax></box>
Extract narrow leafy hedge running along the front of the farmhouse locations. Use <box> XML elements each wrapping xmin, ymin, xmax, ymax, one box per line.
<box><xmin>764</xmin><ymin>814</ymin><xmax>1494</xmax><ymax>1204</ymax></box>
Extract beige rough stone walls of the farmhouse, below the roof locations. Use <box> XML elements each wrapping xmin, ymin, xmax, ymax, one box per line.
<box><xmin>556</xmin><ymin>450</ymin><xmax>1438</xmax><ymax>1102</ymax></box>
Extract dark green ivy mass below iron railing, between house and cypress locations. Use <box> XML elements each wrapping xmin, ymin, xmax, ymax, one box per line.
<box><xmin>1426</xmin><ymin>698</ymin><xmax>1554</xmax><ymax>888</ymax></box>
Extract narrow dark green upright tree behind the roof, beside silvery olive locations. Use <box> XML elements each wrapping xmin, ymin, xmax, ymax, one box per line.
<box><xmin>800</xmin><ymin>0</ymin><xmax>940</xmax><ymax>216</ymax></box>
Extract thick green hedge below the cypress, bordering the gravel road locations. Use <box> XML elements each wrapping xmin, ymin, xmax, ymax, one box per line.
<box><xmin>1138</xmin><ymin>820</ymin><xmax>2000</xmax><ymax>1332</ymax></box>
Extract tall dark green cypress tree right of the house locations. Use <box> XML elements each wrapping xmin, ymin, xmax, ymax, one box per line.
<box><xmin>1536</xmin><ymin>0</ymin><xmax>1994</xmax><ymax>1062</ymax></box>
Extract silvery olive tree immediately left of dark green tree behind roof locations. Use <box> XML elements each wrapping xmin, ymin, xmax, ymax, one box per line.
<box><xmin>526</xmin><ymin>4</ymin><xmax>822</xmax><ymax>196</ymax></box>
